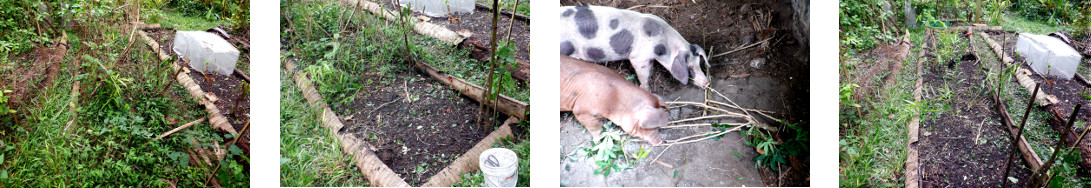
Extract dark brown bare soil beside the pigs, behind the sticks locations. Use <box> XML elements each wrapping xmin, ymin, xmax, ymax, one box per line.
<box><xmin>561</xmin><ymin>0</ymin><xmax>810</xmax><ymax>186</ymax></box>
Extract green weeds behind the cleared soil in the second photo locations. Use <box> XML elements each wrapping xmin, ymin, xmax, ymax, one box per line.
<box><xmin>281</xmin><ymin>2</ymin><xmax>529</xmax><ymax>106</ymax></box>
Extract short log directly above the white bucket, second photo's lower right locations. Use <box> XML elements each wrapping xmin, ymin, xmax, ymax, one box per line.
<box><xmin>421</xmin><ymin>117</ymin><xmax>519</xmax><ymax>187</ymax></box>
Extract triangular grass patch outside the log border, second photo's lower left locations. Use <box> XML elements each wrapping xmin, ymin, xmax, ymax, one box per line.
<box><xmin>280</xmin><ymin>68</ymin><xmax>368</xmax><ymax>187</ymax></box>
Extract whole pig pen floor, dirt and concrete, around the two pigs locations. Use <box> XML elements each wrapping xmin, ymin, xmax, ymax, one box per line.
<box><xmin>561</xmin><ymin>0</ymin><xmax>810</xmax><ymax>184</ymax></box>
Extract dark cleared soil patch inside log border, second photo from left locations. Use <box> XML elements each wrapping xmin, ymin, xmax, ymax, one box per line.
<box><xmin>329</xmin><ymin>66</ymin><xmax>506</xmax><ymax>185</ymax></box>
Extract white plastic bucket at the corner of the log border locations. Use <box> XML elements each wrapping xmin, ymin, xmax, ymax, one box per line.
<box><xmin>478</xmin><ymin>148</ymin><xmax>519</xmax><ymax>187</ymax></box>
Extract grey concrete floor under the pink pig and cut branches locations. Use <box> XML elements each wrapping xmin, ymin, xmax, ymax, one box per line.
<box><xmin>560</xmin><ymin>78</ymin><xmax>788</xmax><ymax>187</ymax></box>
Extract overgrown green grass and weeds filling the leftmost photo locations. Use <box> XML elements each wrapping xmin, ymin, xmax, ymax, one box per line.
<box><xmin>0</xmin><ymin>0</ymin><xmax>250</xmax><ymax>187</ymax></box>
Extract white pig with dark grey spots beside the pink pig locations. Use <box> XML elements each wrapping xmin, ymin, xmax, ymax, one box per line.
<box><xmin>560</xmin><ymin>7</ymin><xmax>708</xmax><ymax>90</ymax></box>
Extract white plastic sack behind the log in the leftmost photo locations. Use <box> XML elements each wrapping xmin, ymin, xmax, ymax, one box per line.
<box><xmin>171</xmin><ymin>31</ymin><xmax>239</xmax><ymax>75</ymax></box>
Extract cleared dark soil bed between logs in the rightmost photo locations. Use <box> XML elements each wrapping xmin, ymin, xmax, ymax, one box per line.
<box><xmin>919</xmin><ymin>51</ymin><xmax>1030</xmax><ymax>187</ymax></box>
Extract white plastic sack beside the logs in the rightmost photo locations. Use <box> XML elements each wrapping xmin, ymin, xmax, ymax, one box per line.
<box><xmin>1016</xmin><ymin>33</ymin><xmax>1082</xmax><ymax>80</ymax></box>
